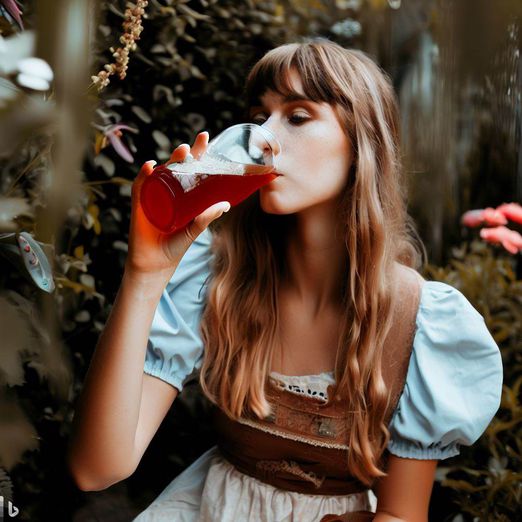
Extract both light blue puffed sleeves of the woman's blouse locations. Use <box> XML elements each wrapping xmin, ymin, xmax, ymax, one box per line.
<box><xmin>144</xmin><ymin>230</ymin><xmax>502</xmax><ymax>460</ymax></box>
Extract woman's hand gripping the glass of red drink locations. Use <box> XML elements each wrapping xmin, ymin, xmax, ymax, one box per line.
<box><xmin>125</xmin><ymin>132</ymin><xmax>230</xmax><ymax>280</ymax></box>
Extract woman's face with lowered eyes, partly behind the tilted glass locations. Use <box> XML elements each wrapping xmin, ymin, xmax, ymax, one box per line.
<box><xmin>250</xmin><ymin>71</ymin><xmax>352</xmax><ymax>214</ymax></box>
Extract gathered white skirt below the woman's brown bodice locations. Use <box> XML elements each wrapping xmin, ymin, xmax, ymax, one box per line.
<box><xmin>134</xmin><ymin>446</ymin><xmax>377</xmax><ymax>522</ymax></box>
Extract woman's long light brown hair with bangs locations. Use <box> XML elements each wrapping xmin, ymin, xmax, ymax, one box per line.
<box><xmin>200</xmin><ymin>39</ymin><xmax>422</xmax><ymax>484</ymax></box>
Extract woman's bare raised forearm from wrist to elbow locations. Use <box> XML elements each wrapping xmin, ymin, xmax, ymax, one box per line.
<box><xmin>68</xmin><ymin>271</ymin><xmax>173</xmax><ymax>489</ymax></box>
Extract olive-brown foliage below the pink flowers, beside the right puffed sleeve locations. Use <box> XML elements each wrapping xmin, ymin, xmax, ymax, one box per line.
<box><xmin>427</xmin><ymin>241</ymin><xmax>522</xmax><ymax>522</ymax></box>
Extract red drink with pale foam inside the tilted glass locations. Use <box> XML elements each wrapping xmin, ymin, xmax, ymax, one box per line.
<box><xmin>140</xmin><ymin>156</ymin><xmax>279</xmax><ymax>233</ymax></box>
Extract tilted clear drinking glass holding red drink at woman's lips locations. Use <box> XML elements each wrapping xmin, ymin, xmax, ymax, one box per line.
<box><xmin>140</xmin><ymin>123</ymin><xmax>281</xmax><ymax>234</ymax></box>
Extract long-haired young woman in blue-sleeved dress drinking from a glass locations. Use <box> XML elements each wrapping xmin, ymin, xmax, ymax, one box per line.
<box><xmin>69</xmin><ymin>39</ymin><xmax>502</xmax><ymax>522</ymax></box>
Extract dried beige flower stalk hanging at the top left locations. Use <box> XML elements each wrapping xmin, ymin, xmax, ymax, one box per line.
<box><xmin>91</xmin><ymin>0</ymin><xmax>149</xmax><ymax>92</ymax></box>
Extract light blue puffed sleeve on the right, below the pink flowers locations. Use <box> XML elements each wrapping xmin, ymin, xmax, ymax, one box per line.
<box><xmin>389</xmin><ymin>274</ymin><xmax>503</xmax><ymax>458</ymax></box>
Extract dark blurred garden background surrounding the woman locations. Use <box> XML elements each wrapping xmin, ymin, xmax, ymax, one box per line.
<box><xmin>0</xmin><ymin>0</ymin><xmax>522</xmax><ymax>522</ymax></box>
